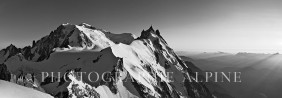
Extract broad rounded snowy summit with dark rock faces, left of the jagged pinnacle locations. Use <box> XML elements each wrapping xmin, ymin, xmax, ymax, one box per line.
<box><xmin>0</xmin><ymin>23</ymin><xmax>135</xmax><ymax>63</ymax></box>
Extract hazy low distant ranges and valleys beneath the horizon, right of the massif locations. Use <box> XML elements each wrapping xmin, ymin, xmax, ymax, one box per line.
<box><xmin>181</xmin><ymin>52</ymin><xmax>282</xmax><ymax>98</ymax></box>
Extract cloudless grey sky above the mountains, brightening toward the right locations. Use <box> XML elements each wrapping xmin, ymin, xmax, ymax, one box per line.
<box><xmin>0</xmin><ymin>0</ymin><xmax>282</xmax><ymax>52</ymax></box>
